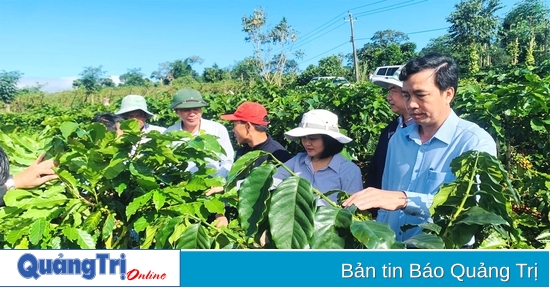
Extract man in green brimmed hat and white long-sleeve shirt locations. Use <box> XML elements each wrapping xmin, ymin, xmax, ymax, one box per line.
<box><xmin>164</xmin><ymin>88</ymin><xmax>235</xmax><ymax>178</ymax></box>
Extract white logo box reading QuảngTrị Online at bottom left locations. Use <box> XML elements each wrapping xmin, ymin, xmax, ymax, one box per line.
<box><xmin>0</xmin><ymin>249</ymin><xmax>181</xmax><ymax>287</ymax></box>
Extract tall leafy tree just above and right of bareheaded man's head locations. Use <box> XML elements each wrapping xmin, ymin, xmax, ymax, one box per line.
<box><xmin>447</xmin><ymin>0</ymin><xmax>502</xmax><ymax>73</ymax></box>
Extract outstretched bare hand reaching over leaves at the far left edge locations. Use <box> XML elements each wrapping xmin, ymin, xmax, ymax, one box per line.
<box><xmin>13</xmin><ymin>154</ymin><xmax>58</xmax><ymax>189</ymax></box>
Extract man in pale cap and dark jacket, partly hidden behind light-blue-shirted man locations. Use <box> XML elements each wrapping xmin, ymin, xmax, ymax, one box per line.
<box><xmin>365</xmin><ymin>68</ymin><xmax>414</xmax><ymax>217</ymax></box>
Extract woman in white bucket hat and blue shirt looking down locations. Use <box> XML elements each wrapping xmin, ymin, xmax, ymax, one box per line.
<box><xmin>274</xmin><ymin>109</ymin><xmax>363</xmax><ymax>206</ymax></box>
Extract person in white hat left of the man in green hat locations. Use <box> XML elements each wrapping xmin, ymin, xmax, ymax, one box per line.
<box><xmin>115</xmin><ymin>95</ymin><xmax>166</xmax><ymax>133</ymax></box>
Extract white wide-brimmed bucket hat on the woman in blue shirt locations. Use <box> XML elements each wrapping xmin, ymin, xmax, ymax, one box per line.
<box><xmin>285</xmin><ymin>109</ymin><xmax>352</xmax><ymax>144</ymax></box>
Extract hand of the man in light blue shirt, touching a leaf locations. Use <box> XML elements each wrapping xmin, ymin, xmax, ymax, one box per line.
<box><xmin>342</xmin><ymin>187</ymin><xmax>407</xmax><ymax>211</ymax></box>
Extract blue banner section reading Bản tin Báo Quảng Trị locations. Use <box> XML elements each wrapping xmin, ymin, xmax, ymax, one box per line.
<box><xmin>180</xmin><ymin>250</ymin><xmax>550</xmax><ymax>287</ymax></box>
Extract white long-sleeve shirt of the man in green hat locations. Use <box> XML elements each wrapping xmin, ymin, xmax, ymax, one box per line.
<box><xmin>164</xmin><ymin>118</ymin><xmax>235</xmax><ymax>178</ymax></box>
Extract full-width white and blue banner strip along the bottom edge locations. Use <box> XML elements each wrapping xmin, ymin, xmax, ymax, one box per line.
<box><xmin>0</xmin><ymin>249</ymin><xmax>550</xmax><ymax>287</ymax></box>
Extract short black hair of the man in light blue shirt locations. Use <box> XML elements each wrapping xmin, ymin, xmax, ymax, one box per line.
<box><xmin>399</xmin><ymin>53</ymin><xmax>458</xmax><ymax>93</ymax></box>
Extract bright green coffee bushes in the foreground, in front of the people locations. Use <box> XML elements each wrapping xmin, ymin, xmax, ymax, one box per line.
<box><xmin>0</xmin><ymin>120</ymin><xmax>518</xmax><ymax>249</ymax></box>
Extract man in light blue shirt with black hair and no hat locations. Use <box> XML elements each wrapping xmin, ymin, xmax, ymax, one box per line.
<box><xmin>344</xmin><ymin>54</ymin><xmax>496</xmax><ymax>241</ymax></box>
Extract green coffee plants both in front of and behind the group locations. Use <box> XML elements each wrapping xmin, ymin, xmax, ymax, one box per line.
<box><xmin>0</xmin><ymin>62</ymin><xmax>550</xmax><ymax>248</ymax></box>
